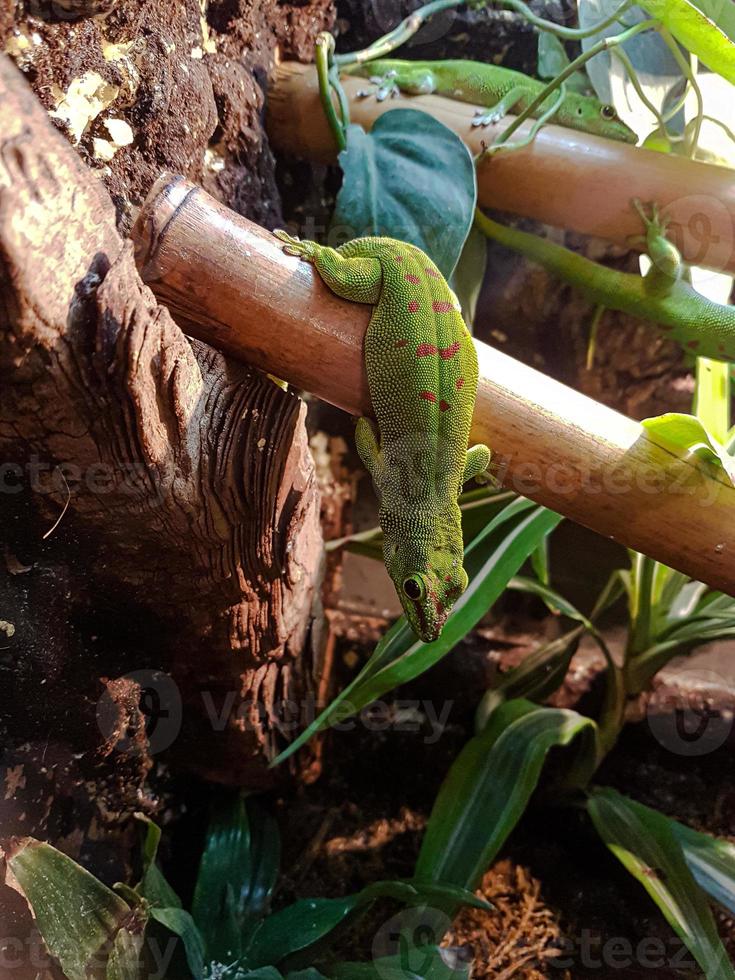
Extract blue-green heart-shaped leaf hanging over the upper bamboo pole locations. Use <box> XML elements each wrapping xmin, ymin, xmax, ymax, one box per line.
<box><xmin>332</xmin><ymin>109</ymin><xmax>477</xmax><ymax>279</ymax></box>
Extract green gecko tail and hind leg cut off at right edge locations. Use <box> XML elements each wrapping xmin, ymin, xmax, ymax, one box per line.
<box><xmin>475</xmin><ymin>201</ymin><xmax>735</xmax><ymax>361</ymax></box>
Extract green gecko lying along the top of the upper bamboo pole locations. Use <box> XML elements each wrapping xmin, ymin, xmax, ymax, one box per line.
<box><xmin>345</xmin><ymin>58</ymin><xmax>637</xmax><ymax>143</ymax></box>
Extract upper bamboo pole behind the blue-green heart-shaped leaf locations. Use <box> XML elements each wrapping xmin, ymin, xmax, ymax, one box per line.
<box><xmin>268</xmin><ymin>62</ymin><xmax>735</xmax><ymax>273</ymax></box>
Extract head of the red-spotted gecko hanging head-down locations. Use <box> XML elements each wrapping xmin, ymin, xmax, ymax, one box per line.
<box><xmin>386</xmin><ymin>546</ymin><xmax>467</xmax><ymax>643</ymax></box>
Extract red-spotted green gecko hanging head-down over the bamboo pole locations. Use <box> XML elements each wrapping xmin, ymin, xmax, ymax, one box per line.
<box><xmin>274</xmin><ymin>231</ymin><xmax>490</xmax><ymax>643</ymax></box>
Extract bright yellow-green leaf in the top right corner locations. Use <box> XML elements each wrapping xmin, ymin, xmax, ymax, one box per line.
<box><xmin>639</xmin><ymin>0</ymin><xmax>735</xmax><ymax>84</ymax></box>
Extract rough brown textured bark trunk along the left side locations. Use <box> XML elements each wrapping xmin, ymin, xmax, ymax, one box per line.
<box><xmin>0</xmin><ymin>47</ymin><xmax>322</xmax><ymax>879</ymax></box>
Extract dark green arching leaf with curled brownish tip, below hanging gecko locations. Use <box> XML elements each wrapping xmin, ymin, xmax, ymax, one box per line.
<box><xmin>416</xmin><ymin>700</ymin><xmax>596</xmax><ymax>888</ymax></box>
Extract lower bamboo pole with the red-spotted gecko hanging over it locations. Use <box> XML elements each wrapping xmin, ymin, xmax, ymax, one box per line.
<box><xmin>133</xmin><ymin>175</ymin><xmax>735</xmax><ymax>593</ymax></box>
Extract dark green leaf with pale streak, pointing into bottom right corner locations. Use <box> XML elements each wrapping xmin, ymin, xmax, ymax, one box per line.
<box><xmin>587</xmin><ymin>788</ymin><xmax>735</xmax><ymax>980</ymax></box>
